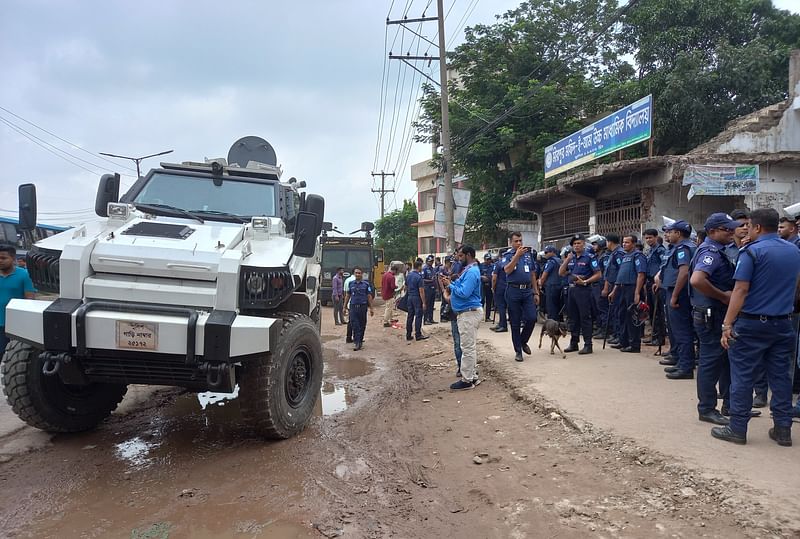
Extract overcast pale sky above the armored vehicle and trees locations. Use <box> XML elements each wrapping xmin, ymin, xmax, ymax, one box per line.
<box><xmin>0</xmin><ymin>0</ymin><xmax>799</xmax><ymax>232</ymax></box>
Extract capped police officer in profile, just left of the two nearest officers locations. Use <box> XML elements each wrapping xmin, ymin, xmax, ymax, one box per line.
<box><xmin>661</xmin><ymin>221</ymin><xmax>696</xmax><ymax>380</ymax></box>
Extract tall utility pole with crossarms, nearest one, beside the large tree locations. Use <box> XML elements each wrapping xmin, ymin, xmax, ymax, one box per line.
<box><xmin>390</xmin><ymin>0</ymin><xmax>456</xmax><ymax>251</ymax></box>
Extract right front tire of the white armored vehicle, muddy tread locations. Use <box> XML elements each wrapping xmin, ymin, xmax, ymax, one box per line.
<box><xmin>239</xmin><ymin>313</ymin><xmax>322</xmax><ymax>439</ymax></box>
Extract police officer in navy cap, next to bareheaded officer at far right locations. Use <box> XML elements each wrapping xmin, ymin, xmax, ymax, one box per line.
<box><xmin>689</xmin><ymin>213</ymin><xmax>739</xmax><ymax>425</ymax></box>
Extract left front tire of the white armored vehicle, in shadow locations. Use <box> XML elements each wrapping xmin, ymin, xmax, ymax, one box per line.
<box><xmin>2</xmin><ymin>341</ymin><xmax>128</xmax><ymax>432</ymax></box>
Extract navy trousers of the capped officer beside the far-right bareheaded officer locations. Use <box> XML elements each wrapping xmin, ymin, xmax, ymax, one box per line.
<box><xmin>692</xmin><ymin>308</ymin><xmax>731</xmax><ymax>414</ymax></box>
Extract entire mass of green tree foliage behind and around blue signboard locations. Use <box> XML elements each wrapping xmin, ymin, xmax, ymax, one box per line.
<box><xmin>415</xmin><ymin>0</ymin><xmax>800</xmax><ymax>244</ymax></box>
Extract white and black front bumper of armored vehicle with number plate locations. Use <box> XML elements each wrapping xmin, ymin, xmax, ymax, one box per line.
<box><xmin>6</xmin><ymin>298</ymin><xmax>282</xmax><ymax>392</ymax></box>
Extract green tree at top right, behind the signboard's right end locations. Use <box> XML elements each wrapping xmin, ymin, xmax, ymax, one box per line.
<box><xmin>620</xmin><ymin>0</ymin><xmax>800</xmax><ymax>154</ymax></box>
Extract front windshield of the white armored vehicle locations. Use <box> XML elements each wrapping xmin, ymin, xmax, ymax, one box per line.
<box><xmin>133</xmin><ymin>173</ymin><xmax>276</xmax><ymax>217</ymax></box>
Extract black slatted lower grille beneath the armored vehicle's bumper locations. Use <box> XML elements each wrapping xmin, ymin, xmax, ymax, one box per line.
<box><xmin>80</xmin><ymin>350</ymin><xmax>206</xmax><ymax>389</ymax></box>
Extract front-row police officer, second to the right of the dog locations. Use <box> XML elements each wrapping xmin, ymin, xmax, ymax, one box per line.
<box><xmin>608</xmin><ymin>234</ymin><xmax>647</xmax><ymax>354</ymax></box>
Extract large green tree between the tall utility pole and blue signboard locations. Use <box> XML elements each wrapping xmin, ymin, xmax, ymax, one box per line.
<box><xmin>416</xmin><ymin>0</ymin><xmax>631</xmax><ymax>244</ymax></box>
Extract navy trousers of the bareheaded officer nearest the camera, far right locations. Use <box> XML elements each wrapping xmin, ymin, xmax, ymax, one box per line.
<box><xmin>728</xmin><ymin>318</ymin><xmax>796</xmax><ymax>434</ymax></box>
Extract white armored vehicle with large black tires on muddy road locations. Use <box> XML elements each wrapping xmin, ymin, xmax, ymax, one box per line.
<box><xmin>2</xmin><ymin>137</ymin><xmax>325</xmax><ymax>438</ymax></box>
